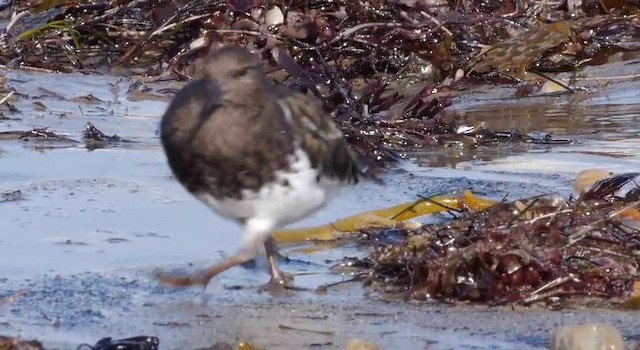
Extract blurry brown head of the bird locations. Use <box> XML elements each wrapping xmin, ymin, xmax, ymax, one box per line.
<box><xmin>205</xmin><ymin>46</ymin><xmax>265</xmax><ymax>96</ymax></box>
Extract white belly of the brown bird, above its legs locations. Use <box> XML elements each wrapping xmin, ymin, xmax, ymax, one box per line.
<box><xmin>197</xmin><ymin>150</ymin><xmax>341</xmax><ymax>230</ymax></box>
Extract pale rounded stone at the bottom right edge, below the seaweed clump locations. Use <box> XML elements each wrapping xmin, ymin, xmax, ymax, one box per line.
<box><xmin>551</xmin><ymin>323</ymin><xmax>626</xmax><ymax>350</ymax></box>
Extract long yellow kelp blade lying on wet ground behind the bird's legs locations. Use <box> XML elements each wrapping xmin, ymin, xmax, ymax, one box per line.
<box><xmin>273</xmin><ymin>190</ymin><xmax>495</xmax><ymax>243</ymax></box>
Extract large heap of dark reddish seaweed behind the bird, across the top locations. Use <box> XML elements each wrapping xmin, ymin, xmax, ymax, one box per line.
<box><xmin>6</xmin><ymin>0</ymin><xmax>640</xmax><ymax>163</ymax></box>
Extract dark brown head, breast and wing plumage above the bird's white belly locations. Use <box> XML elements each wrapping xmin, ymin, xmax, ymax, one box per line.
<box><xmin>160</xmin><ymin>45</ymin><xmax>372</xmax><ymax>199</ymax></box>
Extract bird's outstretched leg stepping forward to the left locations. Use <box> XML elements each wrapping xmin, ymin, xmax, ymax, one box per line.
<box><xmin>156</xmin><ymin>239</ymin><xmax>261</xmax><ymax>287</ymax></box>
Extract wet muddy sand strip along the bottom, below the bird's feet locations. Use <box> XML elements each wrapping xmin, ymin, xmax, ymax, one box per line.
<box><xmin>5</xmin><ymin>270</ymin><xmax>640</xmax><ymax>349</ymax></box>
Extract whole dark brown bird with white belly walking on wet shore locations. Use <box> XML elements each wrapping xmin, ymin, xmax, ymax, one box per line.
<box><xmin>158</xmin><ymin>46</ymin><xmax>375</xmax><ymax>292</ymax></box>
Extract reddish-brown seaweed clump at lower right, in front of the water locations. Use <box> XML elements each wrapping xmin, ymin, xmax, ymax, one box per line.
<box><xmin>359</xmin><ymin>173</ymin><xmax>640</xmax><ymax>308</ymax></box>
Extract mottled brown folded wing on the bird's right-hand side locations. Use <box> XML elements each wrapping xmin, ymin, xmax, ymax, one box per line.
<box><xmin>276</xmin><ymin>86</ymin><xmax>377</xmax><ymax>183</ymax></box>
